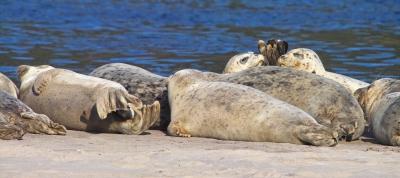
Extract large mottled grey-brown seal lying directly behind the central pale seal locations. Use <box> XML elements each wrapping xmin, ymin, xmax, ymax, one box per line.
<box><xmin>206</xmin><ymin>66</ymin><xmax>365</xmax><ymax>141</ymax></box>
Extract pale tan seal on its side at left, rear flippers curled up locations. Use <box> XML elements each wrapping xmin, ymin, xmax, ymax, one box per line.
<box><xmin>18</xmin><ymin>65</ymin><xmax>160</xmax><ymax>134</ymax></box>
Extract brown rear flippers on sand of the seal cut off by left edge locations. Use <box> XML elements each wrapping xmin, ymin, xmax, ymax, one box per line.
<box><xmin>21</xmin><ymin>111</ymin><xmax>67</xmax><ymax>135</ymax></box>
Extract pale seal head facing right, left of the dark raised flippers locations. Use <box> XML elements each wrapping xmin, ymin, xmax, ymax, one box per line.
<box><xmin>223</xmin><ymin>52</ymin><xmax>267</xmax><ymax>73</ymax></box>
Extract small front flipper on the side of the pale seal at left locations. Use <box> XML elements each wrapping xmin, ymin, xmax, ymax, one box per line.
<box><xmin>32</xmin><ymin>69</ymin><xmax>63</xmax><ymax>95</ymax></box>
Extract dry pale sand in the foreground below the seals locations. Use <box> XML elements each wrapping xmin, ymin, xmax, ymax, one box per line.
<box><xmin>0</xmin><ymin>131</ymin><xmax>400</xmax><ymax>178</ymax></box>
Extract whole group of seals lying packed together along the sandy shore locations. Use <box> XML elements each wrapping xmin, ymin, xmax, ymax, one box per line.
<box><xmin>0</xmin><ymin>40</ymin><xmax>400</xmax><ymax>146</ymax></box>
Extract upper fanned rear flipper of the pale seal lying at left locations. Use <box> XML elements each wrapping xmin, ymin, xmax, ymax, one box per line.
<box><xmin>96</xmin><ymin>88</ymin><xmax>143</xmax><ymax>119</ymax></box>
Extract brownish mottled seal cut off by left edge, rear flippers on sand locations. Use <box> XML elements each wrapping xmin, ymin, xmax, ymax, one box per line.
<box><xmin>0</xmin><ymin>91</ymin><xmax>67</xmax><ymax>140</ymax></box>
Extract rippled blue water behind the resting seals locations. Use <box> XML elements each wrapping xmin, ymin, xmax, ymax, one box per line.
<box><xmin>0</xmin><ymin>0</ymin><xmax>400</xmax><ymax>81</ymax></box>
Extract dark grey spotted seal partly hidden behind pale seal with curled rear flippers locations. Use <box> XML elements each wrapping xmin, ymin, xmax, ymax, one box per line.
<box><xmin>89</xmin><ymin>63</ymin><xmax>170</xmax><ymax>129</ymax></box>
